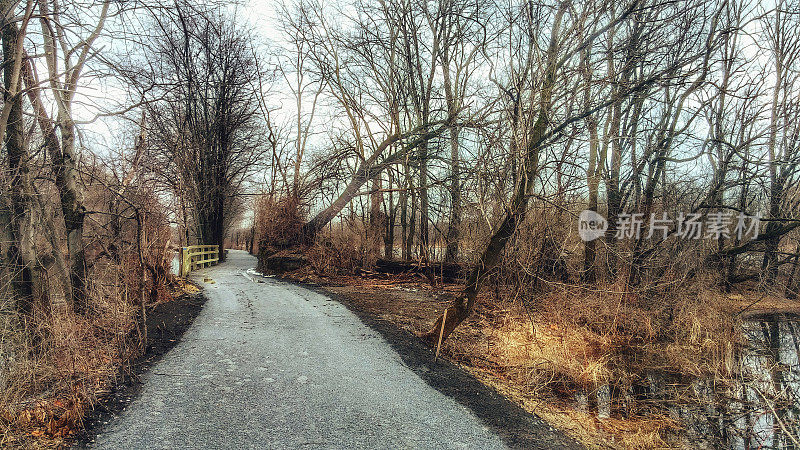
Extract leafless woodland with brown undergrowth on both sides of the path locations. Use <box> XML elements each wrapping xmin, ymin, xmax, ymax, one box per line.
<box><xmin>0</xmin><ymin>0</ymin><xmax>800</xmax><ymax>448</ymax></box>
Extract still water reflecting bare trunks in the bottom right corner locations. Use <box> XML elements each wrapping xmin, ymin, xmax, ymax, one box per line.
<box><xmin>670</xmin><ymin>315</ymin><xmax>800</xmax><ymax>450</ymax></box>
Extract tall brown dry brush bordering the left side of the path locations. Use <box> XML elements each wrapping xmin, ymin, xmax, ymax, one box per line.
<box><xmin>0</xmin><ymin>256</ymin><xmax>180</xmax><ymax>448</ymax></box>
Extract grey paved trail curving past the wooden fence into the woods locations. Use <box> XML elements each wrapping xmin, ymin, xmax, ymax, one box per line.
<box><xmin>94</xmin><ymin>251</ymin><xmax>576</xmax><ymax>449</ymax></box>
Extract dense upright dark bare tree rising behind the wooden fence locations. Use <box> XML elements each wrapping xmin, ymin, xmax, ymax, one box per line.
<box><xmin>124</xmin><ymin>3</ymin><xmax>264</xmax><ymax>258</ymax></box>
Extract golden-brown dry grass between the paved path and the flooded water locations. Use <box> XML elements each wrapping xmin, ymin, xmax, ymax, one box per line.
<box><xmin>456</xmin><ymin>289</ymin><xmax>743</xmax><ymax>448</ymax></box>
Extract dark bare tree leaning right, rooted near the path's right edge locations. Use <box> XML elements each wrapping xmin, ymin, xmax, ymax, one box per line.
<box><xmin>423</xmin><ymin>1</ymin><xmax>715</xmax><ymax>344</ymax></box>
